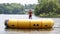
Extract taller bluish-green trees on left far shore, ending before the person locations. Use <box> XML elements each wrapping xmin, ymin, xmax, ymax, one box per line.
<box><xmin>0</xmin><ymin>3</ymin><xmax>24</xmax><ymax>14</ymax></box>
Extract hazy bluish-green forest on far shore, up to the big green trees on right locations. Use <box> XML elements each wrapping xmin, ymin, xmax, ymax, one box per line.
<box><xmin>0</xmin><ymin>3</ymin><xmax>35</xmax><ymax>14</ymax></box>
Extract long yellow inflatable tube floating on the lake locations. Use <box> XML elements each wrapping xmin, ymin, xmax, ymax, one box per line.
<box><xmin>5</xmin><ymin>19</ymin><xmax>54</xmax><ymax>28</ymax></box>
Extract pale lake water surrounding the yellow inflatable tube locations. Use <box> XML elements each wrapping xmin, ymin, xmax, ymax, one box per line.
<box><xmin>0</xmin><ymin>14</ymin><xmax>60</xmax><ymax>34</ymax></box>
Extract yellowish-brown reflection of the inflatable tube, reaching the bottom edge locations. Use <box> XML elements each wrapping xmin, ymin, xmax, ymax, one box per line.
<box><xmin>5</xmin><ymin>28</ymin><xmax>53</xmax><ymax>34</ymax></box>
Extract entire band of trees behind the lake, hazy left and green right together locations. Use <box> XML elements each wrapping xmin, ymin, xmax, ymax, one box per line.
<box><xmin>0</xmin><ymin>0</ymin><xmax>60</xmax><ymax>17</ymax></box>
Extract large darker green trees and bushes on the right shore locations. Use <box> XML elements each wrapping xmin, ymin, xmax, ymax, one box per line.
<box><xmin>34</xmin><ymin>0</ymin><xmax>60</xmax><ymax>16</ymax></box>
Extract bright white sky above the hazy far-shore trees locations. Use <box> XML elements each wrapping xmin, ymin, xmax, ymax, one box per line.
<box><xmin>0</xmin><ymin>0</ymin><xmax>38</xmax><ymax>5</ymax></box>
